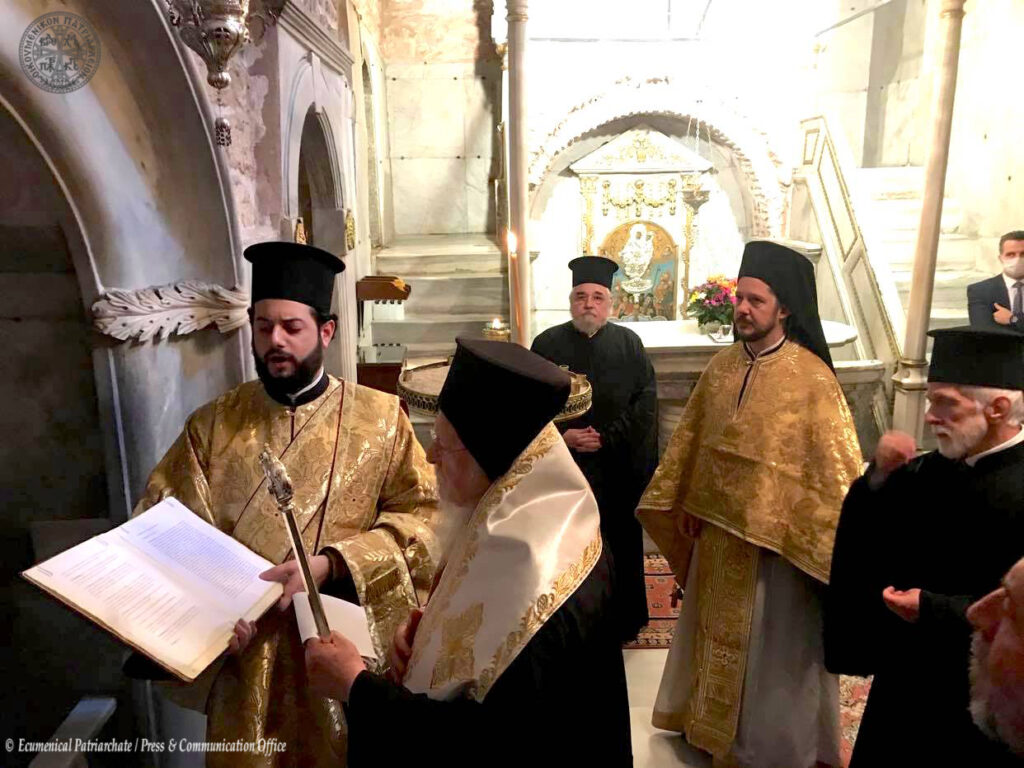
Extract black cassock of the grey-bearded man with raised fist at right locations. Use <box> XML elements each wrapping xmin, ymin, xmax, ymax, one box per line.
<box><xmin>824</xmin><ymin>444</ymin><xmax>1024</xmax><ymax>768</ymax></box>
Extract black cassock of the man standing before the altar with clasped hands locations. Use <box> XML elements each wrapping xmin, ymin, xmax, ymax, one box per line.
<box><xmin>531</xmin><ymin>322</ymin><xmax>657</xmax><ymax>640</ymax></box>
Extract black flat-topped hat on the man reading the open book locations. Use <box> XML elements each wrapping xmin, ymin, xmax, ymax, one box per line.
<box><xmin>244</xmin><ymin>241</ymin><xmax>345</xmax><ymax>314</ymax></box>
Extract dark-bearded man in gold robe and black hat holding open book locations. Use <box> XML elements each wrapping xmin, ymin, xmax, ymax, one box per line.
<box><xmin>135</xmin><ymin>243</ymin><xmax>437</xmax><ymax>768</ymax></box>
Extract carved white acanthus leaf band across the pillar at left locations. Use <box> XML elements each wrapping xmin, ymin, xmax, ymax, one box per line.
<box><xmin>92</xmin><ymin>281</ymin><xmax>249</xmax><ymax>341</ymax></box>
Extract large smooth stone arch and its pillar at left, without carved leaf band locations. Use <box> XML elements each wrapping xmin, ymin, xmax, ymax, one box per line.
<box><xmin>0</xmin><ymin>0</ymin><xmax>242</xmax><ymax>521</ymax></box>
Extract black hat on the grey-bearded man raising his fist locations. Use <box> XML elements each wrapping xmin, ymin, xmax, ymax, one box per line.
<box><xmin>928</xmin><ymin>326</ymin><xmax>1024</xmax><ymax>389</ymax></box>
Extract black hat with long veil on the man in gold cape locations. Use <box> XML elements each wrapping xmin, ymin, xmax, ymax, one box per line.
<box><xmin>736</xmin><ymin>240</ymin><xmax>836</xmax><ymax>371</ymax></box>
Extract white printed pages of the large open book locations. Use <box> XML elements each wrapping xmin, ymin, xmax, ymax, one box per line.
<box><xmin>24</xmin><ymin>499</ymin><xmax>284</xmax><ymax>680</ymax></box>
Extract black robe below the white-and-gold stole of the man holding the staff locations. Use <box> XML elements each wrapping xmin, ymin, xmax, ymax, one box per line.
<box><xmin>345</xmin><ymin>555</ymin><xmax>633</xmax><ymax>768</ymax></box>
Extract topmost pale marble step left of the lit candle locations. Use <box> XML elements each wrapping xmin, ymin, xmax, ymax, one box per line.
<box><xmin>374</xmin><ymin>234</ymin><xmax>505</xmax><ymax>280</ymax></box>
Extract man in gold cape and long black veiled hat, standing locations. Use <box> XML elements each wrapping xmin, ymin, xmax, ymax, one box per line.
<box><xmin>638</xmin><ymin>242</ymin><xmax>861</xmax><ymax>768</ymax></box>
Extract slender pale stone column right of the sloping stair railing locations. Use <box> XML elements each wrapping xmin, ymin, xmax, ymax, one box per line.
<box><xmin>893</xmin><ymin>0</ymin><xmax>965</xmax><ymax>442</ymax></box>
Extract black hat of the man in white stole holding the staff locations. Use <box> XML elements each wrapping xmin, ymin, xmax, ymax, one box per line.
<box><xmin>438</xmin><ymin>338</ymin><xmax>571</xmax><ymax>480</ymax></box>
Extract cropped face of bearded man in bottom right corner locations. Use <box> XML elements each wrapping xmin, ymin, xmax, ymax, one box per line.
<box><xmin>967</xmin><ymin>558</ymin><xmax>1024</xmax><ymax>765</ymax></box>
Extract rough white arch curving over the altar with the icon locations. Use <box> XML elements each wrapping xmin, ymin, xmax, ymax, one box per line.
<box><xmin>527</xmin><ymin>77</ymin><xmax>785</xmax><ymax>238</ymax></box>
